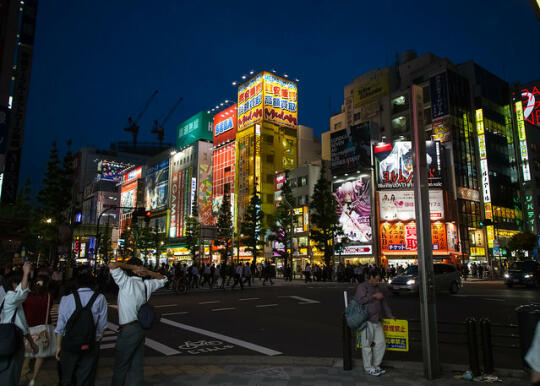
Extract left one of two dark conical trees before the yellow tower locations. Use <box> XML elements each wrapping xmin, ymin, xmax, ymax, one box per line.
<box><xmin>240</xmin><ymin>187</ymin><xmax>264</xmax><ymax>264</ymax></box>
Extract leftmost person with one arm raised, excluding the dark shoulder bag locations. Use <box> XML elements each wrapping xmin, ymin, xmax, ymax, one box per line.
<box><xmin>0</xmin><ymin>262</ymin><xmax>38</xmax><ymax>385</ymax></box>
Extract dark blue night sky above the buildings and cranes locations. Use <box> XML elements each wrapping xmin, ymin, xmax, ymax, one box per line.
<box><xmin>21</xmin><ymin>0</ymin><xmax>540</xmax><ymax>191</ymax></box>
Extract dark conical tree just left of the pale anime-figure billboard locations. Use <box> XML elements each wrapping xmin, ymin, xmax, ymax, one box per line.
<box><xmin>309</xmin><ymin>165</ymin><xmax>343</xmax><ymax>266</ymax></box>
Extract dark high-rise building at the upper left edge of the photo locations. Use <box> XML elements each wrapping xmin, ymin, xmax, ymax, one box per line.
<box><xmin>0</xmin><ymin>0</ymin><xmax>38</xmax><ymax>203</ymax></box>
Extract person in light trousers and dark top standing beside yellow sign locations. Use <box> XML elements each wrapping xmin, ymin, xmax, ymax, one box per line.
<box><xmin>354</xmin><ymin>270</ymin><xmax>395</xmax><ymax>377</ymax></box>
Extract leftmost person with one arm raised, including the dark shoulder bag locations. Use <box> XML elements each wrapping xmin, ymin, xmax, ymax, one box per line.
<box><xmin>0</xmin><ymin>262</ymin><xmax>38</xmax><ymax>386</ymax></box>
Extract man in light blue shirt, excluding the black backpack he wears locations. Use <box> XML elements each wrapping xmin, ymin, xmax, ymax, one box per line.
<box><xmin>55</xmin><ymin>270</ymin><xmax>107</xmax><ymax>386</ymax></box>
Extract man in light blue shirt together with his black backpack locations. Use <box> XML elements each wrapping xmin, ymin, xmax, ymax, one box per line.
<box><xmin>55</xmin><ymin>269</ymin><xmax>107</xmax><ymax>386</ymax></box>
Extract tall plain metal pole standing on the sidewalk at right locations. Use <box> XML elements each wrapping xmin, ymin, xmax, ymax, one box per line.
<box><xmin>409</xmin><ymin>85</ymin><xmax>440</xmax><ymax>379</ymax></box>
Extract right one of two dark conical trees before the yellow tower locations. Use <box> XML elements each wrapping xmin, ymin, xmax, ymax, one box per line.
<box><xmin>268</xmin><ymin>170</ymin><xmax>294</xmax><ymax>269</ymax></box>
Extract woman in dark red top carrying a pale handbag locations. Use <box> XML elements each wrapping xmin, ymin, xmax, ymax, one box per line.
<box><xmin>23</xmin><ymin>275</ymin><xmax>56</xmax><ymax>386</ymax></box>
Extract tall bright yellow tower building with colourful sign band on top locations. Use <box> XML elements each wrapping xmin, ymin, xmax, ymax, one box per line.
<box><xmin>234</xmin><ymin>71</ymin><xmax>298</xmax><ymax>231</ymax></box>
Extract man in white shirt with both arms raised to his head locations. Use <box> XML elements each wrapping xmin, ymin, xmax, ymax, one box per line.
<box><xmin>109</xmin><ymin>258</ymin><xmax>167</xmax><ymax>386</ymax></box>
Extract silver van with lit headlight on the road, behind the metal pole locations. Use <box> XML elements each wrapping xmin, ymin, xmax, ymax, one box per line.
<box><xmin>388</xmin><ymin>264</ymin><xmax>463</xmax><ymax>294</ymax></box>
